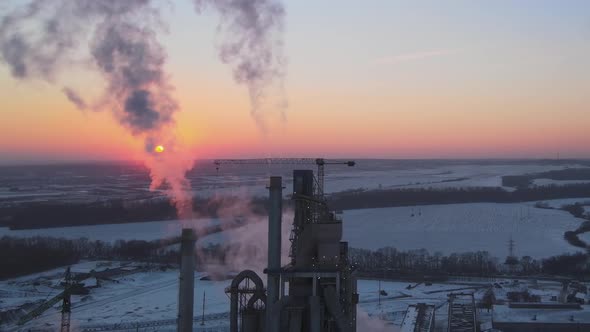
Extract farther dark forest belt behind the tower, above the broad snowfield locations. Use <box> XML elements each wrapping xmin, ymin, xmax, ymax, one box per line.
<box><xmin>0</xmin><ymin>183</ymin><xmax>590</xmax><ymax>229</ymax></box>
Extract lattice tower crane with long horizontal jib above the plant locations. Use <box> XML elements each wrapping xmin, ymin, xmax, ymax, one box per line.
<box><xmin>213</xmin><ymin>158</ymin><xmax>356</xmax><ymax>200</ymax></box>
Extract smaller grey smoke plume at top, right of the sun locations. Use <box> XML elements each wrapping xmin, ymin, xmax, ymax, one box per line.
<box><xmin>193</xmin><ymin>0</ymin><xmax>287</xmax><ymax>131</ymax></box>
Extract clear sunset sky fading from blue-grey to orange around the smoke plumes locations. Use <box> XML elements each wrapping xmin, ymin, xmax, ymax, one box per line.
<box><xmin>0</xmin><ymin>0</ymin><xmax>590</xmax><ymax>163</ymax></box>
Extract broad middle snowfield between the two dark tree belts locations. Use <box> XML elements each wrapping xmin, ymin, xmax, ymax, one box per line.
<box><xmin>0</xmin><ymin>198</ymin><xmax>590</xmax><ymax>258</ymax></box>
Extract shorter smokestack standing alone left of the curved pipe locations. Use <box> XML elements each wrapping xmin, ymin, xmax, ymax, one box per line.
<box><xmin>177</xmin><ymin>228</ymin><xmax>195</xmax><ymax>332</ymax></box>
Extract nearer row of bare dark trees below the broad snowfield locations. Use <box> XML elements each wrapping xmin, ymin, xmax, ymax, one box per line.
<box><xmin>0</xmin><ymin>236</ymin><xmax>590</xmax><ymax>279</ymax></box>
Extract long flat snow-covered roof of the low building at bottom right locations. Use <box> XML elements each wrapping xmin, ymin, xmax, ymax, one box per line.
<box><xmin>493</xmin><ymin>303</ymin><xmax>590</xmax><ymax>324</ymax></box>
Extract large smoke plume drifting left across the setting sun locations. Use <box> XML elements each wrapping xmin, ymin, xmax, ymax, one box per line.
<box><xmin>0</xmin><ymin>0</ymin><xmax>192</xmax><ymax>218</ymax></box>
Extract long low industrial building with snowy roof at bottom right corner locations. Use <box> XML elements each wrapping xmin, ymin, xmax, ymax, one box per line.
<box><xmin>492</xmin><ymin>303</ymin><xmax>590</xmax><ymax>332</ymax></box>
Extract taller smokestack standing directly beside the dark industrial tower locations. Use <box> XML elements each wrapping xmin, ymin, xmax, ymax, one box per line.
<box><xmin>266</xmin><ymin>176</ymin><xmax>283</xmax><ymax>332</ymax></box>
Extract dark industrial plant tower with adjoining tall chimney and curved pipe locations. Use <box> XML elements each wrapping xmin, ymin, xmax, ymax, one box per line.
<box><xmin>226</xmin><ymin>170</ymin><xmax>358</xmax><ymax>332</ymax></box>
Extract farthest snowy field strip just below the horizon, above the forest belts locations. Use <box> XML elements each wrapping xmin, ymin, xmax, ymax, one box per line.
<box><xmin>212</xmin><ymin>160</ymin><xmax>584</xmax><ymax>196</ymax></box>
